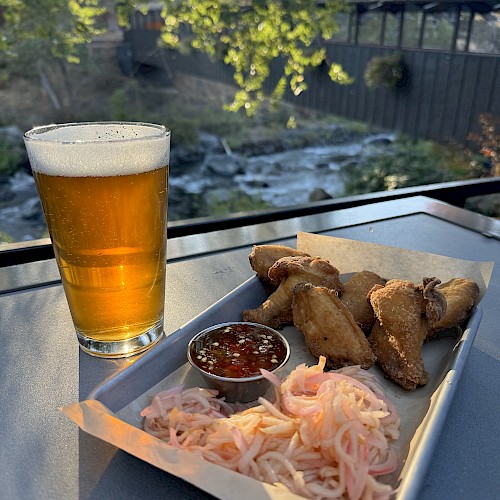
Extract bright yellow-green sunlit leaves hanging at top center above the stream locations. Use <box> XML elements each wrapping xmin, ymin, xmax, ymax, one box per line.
<box><xmin>156</xmin><ymin>0</ymin><xmax>351</xmax><ymax>115</ymax></box>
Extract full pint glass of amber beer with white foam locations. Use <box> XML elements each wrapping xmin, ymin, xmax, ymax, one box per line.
<box><xmin>24</xmin><ymin>122</ymin><xmax>170</xmax><ymax>357</ymax></box>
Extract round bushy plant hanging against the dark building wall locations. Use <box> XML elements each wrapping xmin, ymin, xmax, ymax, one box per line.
<box><xmin>364</xmin><ymin>52</ymin><xmax>407</xmax><ymax>90</ymax></box>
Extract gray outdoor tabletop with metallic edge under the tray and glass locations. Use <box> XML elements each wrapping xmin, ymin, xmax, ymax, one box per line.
<box><xmin>0</xmin><ymin>197</ymin><xmax>500</xmax><ymax>500</ymax></box>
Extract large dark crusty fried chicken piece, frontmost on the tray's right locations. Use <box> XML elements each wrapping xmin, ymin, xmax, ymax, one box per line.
<box><xmin>368</xmin><ymin>279</ymin><xmax>429</xmax><ymax>390</ymax></box>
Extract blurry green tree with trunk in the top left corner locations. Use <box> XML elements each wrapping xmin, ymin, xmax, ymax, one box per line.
<box><xmin>0</xmin><ymin>0</ymin><xmax>109</xmax><ymax>121</ymax></box>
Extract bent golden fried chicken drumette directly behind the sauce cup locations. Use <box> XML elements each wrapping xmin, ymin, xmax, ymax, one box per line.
<box><xmin>243</xmin><ymin>257</ymin><xmax>342</xmax><ymax>328</ymax></box>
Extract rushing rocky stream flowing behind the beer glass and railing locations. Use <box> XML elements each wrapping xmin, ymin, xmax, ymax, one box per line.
<box><xmin>0</xmin><ymin>133</ymin><xmax>394</xmax><ymax>242</ymax></box>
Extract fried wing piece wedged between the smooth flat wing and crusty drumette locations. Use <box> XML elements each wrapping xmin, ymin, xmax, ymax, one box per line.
<box><xmin>340</xmin><ymin>271</ymin><xmax>386</xmax><ymax>334</ymax></box>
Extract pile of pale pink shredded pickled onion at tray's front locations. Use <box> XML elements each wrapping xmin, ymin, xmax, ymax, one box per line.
<box><xmin>141</xmin><ymin>357</ymin><xmax>399</xmax><ymax>499</ymax></box>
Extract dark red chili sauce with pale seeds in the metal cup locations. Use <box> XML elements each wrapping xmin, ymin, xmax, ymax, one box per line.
<box><xmin>190</xmin><ymin>323</ymin><xmax>287</xmax><ymax>378</ymax></box>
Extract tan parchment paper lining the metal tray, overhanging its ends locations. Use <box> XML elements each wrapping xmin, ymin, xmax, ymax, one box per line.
<box><xmin>61</xmin><ymin>233</ymin><xmax>493</xmax><ymax>500</ymax></box>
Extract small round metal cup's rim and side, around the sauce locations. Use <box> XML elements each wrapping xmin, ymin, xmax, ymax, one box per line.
<box><xmin>187</xmin><ymin>321</ymin><xmax>290</xmax><ymax>403</ymax></box>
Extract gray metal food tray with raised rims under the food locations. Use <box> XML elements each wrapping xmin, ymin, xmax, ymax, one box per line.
<box><xmin>87</xmin><ymin>276</ymin><xmax>482</xmax><ymax>500</ymax></box>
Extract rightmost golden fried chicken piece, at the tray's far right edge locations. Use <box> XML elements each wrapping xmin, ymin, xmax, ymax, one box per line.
<box><xmin>427</xmin><ymin>278</ymin><xmax>479</xmax><ymax>339</ymax></box>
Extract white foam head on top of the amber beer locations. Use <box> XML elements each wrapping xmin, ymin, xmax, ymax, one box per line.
<box><xmin>25</xmin><ymin>123</ymin><xmax>170</xmax><ymax>177</ymax></box>
